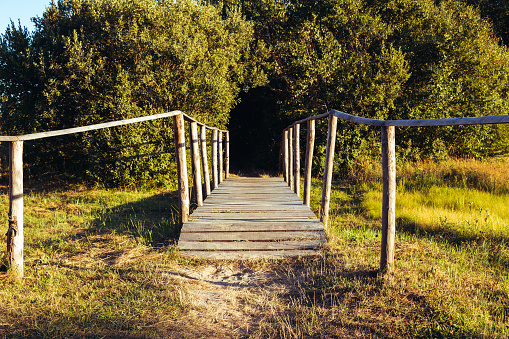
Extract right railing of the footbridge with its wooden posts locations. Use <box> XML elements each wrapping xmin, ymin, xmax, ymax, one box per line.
<box><xmin>282</xmin><ymin>110</ymin><xmax>509</xmax><ymax>271</ymax></box>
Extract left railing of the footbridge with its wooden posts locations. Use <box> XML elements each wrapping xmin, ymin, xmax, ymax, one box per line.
<box><xmin>0</xmin><ymin>111</ymin><xmax>230</xmax><ymax>279</ymax></box>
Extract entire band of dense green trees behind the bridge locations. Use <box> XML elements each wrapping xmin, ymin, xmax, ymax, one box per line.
<box><xmin>0</xmin><ymin>0</ymin><xmax>509</xmax><ymax>183</ymax></box>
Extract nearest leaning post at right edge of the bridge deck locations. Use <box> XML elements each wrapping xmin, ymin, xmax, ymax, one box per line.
<box><xmin>320</xmin><ymin>114</ymin><xmax>338</xmax><ymax>227</ymax></box>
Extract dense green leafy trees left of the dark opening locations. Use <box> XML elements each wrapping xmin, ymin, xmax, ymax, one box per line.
<box><xmin>0</xmin><ymin>0</ymin><xmax>264</xmax><ymax>184</ymax></box>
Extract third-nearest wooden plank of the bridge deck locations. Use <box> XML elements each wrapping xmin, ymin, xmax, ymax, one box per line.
<box><xmin>179</xmin><ymin>231</ymin><xmax>325</xmax><ymax>241</ymax></box>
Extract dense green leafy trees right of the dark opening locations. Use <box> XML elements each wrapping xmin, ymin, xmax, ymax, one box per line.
<box><xmin>221</xmin><ymin>0</ymin><xmax>509</xmax><ymax>174</ymax></box>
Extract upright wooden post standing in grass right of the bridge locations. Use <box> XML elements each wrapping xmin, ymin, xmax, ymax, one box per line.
<box><xmin>380</xmin><ymin>126</ymin><xmax>396</xmax><ymax>271</ymax></box>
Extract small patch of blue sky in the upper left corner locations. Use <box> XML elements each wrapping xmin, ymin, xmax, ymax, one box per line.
<box><xmin>0</xmin><ymin>0</ymin><xmax>51</xmax><ymax>33</ymax></box>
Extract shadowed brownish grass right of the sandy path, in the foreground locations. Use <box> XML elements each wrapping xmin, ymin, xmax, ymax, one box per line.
<box><xmin>264</xmin><ymin>255</ymin><xmax>469</xmax><ymax>338</ymax></box>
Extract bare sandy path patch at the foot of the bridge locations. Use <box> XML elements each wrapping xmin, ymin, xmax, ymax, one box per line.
<box><xmin>168</xmin><ymin>263</ymin><xmax>288</xmax><ymax>338</ymax></box>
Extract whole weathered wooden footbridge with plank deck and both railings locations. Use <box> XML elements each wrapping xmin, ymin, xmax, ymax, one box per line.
<box><xmin>0</xmin><ymin>110</ymin><xmax>509</xmax><ymax>278</ymax></box>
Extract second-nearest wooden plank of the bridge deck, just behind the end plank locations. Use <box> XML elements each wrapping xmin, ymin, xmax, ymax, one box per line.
<box><xmin>179</xmin><ymin>240</ymin><xmax>326</xmax><ymax>251</ymax></box>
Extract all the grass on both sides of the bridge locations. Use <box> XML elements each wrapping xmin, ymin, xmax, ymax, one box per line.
<box><xmin>0</xmin><ymin>160</ymin><xmax>509</xmax><ymax>338</ymax></box>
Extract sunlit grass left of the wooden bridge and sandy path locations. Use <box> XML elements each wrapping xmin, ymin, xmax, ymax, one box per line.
<box><xmin>0</xmin><ymin>187</ymin><xmax>186</xmax><ymax>338</ymax></box>
